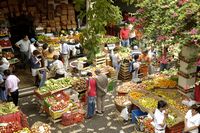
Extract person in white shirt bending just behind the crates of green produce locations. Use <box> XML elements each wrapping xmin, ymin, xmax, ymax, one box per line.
<box><xmin>50</xmin><ymin>55</ymin><xmax>66</xmax><ymax>79</ymax></box>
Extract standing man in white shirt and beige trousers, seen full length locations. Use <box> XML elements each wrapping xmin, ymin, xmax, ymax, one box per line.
<box><xmin>60</xmin><ymin>40</ymin><xmax>70</xmax><ymax>70</ymax></box>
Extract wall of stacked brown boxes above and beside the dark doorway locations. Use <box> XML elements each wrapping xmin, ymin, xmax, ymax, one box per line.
<box><xmin>0</xmin><ymin>0</ymin><xmax>77</xmax><ymax>32</ymax></box>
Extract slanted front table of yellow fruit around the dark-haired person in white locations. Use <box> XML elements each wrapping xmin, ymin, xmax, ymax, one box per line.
<box><xmin>129</xmin><ymin>89</ymin><xmax>186</xmax><ymax>133</ymax></box>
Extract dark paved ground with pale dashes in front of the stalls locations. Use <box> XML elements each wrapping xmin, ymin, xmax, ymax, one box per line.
<box><xmin>19</xmin><ymin>91</ymin><xmax>138</xmax><ymax>133</ymax></box>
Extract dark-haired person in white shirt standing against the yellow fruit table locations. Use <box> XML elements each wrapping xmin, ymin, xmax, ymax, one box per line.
<box><xmin>154</xmin><ymin>100</ymin><xmax>168</xmax><ymax>133</ymax></box>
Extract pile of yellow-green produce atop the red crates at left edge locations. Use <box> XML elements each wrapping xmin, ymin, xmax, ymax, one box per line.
<box><xmin>0</xmin><ymin>102</ymin><xmax>19</xmax><ymax>115</ymax></box>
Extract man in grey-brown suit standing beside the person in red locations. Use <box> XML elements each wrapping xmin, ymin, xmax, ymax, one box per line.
<box><xmin>95</xmin><ymin>69</ymin><xmax>108</xmax><ymax>114</ymax></box>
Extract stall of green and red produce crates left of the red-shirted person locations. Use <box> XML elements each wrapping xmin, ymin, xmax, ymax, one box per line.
<box><xmin>35</xmin><ymin>77</ymin><xmax>86</xmax><ymax>124</ymax></box>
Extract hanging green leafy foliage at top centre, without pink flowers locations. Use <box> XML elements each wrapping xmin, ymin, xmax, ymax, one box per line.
<box><xmin>75</xmin><ymin>0</ymin><xmax>122</xmax><ymax>62</ymax></box>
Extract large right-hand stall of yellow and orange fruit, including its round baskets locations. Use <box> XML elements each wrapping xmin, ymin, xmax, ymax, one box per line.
<box><xmin>114</xmin><ymin>70</ymin><xmax>188</xmax><ymax>132</ymax></box>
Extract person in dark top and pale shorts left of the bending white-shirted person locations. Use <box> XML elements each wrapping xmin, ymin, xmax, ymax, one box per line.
<box><xmin>30</xmin><ymin>50</ymin><xmax>43</xmax><ymax>86</ymax></box>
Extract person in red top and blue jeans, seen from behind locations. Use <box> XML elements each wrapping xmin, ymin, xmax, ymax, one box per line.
<box><xmin>86</xmin><ymin>72</ymin><xmax>96</xmax><ymax>119</ymax></box>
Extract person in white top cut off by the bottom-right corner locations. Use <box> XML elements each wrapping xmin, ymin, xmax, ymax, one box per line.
<box><xmin>184</xmin><ymin>105</ymin><xmax>200</xmax><ymax>133</ymax></box>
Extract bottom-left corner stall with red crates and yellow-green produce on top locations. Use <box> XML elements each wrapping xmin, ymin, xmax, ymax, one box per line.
<box><xmin>0</xmin><ymin>102</ymin><xmax>29</xmax><ymax>133</ymax></box>
